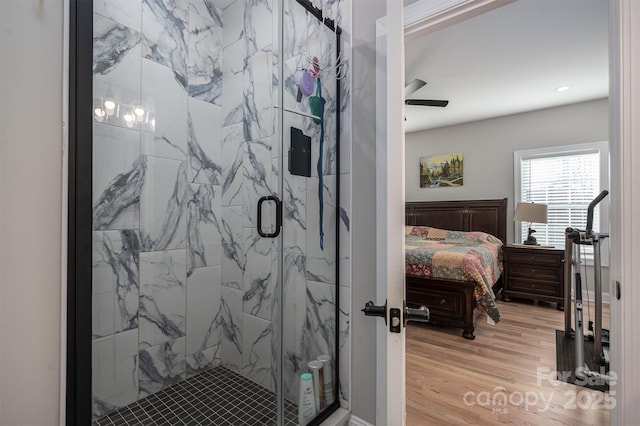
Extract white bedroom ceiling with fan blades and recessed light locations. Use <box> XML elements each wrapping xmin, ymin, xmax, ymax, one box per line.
<box><xmin>405</xmin><ymin>0</ymin><xmax>609</xmax><ymax>133</ymax></box>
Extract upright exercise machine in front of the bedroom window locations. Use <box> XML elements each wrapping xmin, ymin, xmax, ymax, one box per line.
<box><xmin>565</xmin><ymin>190</ymin><xmax>611</xmax><ymax>383</ymax></box>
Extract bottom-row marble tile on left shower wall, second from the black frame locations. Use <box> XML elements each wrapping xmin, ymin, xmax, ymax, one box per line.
<box><xmin>138</xmin><ymin>337</ymin><xmax>186</xmax><ymax>397</ymax></box>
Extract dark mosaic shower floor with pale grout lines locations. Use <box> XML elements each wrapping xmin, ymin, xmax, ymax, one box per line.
<box><xmin>93</xmin><ymin>367</ymin><xmax>298</xmax><ymax>426</ymax></box>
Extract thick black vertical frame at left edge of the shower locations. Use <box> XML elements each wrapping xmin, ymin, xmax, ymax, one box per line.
<box><xmin>61</xmin><ymin>0</ymin><xmax>93</xmax><ymax>426</ymax></box>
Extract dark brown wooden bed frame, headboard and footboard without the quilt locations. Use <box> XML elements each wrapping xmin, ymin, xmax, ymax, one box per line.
<box><xmin>405</xmin><ymin>198</ymin><xmax>507</xmax><ymax>339</ymax></box>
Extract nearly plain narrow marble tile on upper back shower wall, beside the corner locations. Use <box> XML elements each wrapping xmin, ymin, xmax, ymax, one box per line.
<box><xmin>222</xmin><ymin>41</ymin><xmax>244</xmax><ymax>125</ymax></box>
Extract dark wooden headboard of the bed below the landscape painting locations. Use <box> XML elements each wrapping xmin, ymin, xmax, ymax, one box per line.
<box><xmin>405</xmin><ymin>198</ymin><xmax>507</xmax><ymax>244</ymax></box>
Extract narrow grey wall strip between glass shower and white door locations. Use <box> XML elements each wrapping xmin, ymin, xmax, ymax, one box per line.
<box><xmin>351</xmin><ymin>0</ymin><xmax>386</xmax><ymax>424</ymax></box>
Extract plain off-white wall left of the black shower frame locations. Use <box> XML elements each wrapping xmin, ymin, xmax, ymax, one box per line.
<box><xmin>0</xmin><ymin>0</ymin><xmax>63</xmax><ymax>426</ymax></box>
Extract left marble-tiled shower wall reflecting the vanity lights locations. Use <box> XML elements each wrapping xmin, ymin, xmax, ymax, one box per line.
<box><xmin>93</xmin><ymin>0</ymin><xmax>226</xmax><ymax>416</ymax></box>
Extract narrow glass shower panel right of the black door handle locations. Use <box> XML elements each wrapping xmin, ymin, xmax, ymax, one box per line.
<box><xmin>279</xmin><ymin>0</ymin><xmax>339</xmax><ymax>424</ymax></box>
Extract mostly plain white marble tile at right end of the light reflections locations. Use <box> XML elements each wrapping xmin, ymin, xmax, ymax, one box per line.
<box><xmin>139</xmin><ymin>59</ymin><xmax>189</xmax><ymax>160</ymax></box>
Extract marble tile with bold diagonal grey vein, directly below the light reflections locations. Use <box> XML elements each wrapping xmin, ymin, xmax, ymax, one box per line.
<box><xmin>92</xmin><ymin>123</ymin><xmax>141</xmax><ymax>229</ymax></box>
